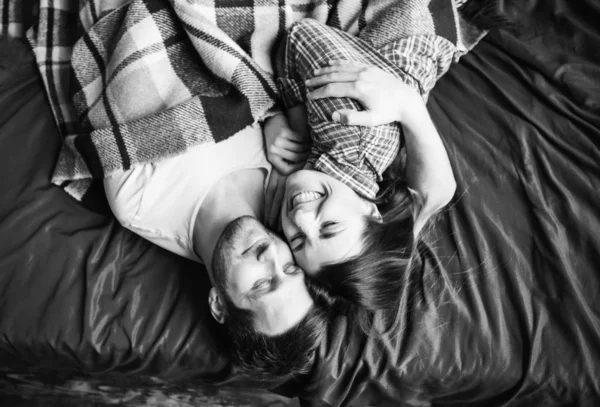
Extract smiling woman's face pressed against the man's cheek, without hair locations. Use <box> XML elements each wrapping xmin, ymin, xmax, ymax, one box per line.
<box><xmin>281</xmin><ymin>170</ymin><xmax>377</xmax><ymax>275</ymax></box>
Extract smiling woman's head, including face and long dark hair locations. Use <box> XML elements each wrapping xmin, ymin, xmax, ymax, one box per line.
<box><xmin>281</xmin><ymin>150</ymin><xmax>426</xmax><ymax>331</ymax></box>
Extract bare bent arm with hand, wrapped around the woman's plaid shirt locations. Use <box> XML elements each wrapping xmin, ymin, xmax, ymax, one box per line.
<box><xmin>306</xmin><ymin>61</ymin><xmax>456</xmax><ymax>233</ymax></box>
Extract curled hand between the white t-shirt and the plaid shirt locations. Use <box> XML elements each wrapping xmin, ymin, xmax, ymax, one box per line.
<box><xmin>263</xmin><ymin>114</ymin><xmax>311</xmax><ymax>175</ymax></box>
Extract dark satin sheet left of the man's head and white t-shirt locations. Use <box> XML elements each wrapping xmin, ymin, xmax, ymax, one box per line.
<box><xmin>0</xmin><ymin>39</ymin><xmax>228</xmax><ymax>378</ymax></box>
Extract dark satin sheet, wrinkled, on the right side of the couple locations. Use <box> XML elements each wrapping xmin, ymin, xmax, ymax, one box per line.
<box><xmin>306</xmin><ymin>0</ymin><xmax>600</xmax><ymax>406</ymax></box>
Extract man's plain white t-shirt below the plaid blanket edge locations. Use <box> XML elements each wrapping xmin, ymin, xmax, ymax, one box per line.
<box><xmin>104</xmin><ymin>125</ymin><xmax>271</xmax><ymax>262</ymax></box>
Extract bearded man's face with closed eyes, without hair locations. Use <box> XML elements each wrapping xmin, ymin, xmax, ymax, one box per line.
<box><xmin>213</xmin><ymin>216</ymin><xmax>313</xmax><ymax>336</ymax></box>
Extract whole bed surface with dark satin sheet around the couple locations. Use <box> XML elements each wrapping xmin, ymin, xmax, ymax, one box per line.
<box><xmin>0</xmin><ymin>0</ymin><xmax>600</xmax><ymax>406</ymax></box>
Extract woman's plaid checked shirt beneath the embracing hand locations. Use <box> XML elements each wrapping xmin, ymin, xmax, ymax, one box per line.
<box><xmin>277</xmin><ymin>19</ymin><xmax>456</xmax><ymax>198</ymax></box>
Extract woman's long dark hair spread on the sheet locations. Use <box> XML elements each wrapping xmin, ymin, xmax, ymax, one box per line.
<box><xmin>314</xmin><ymin>143</ymin><xmax>421</xmax><ymax>333</ymax></box>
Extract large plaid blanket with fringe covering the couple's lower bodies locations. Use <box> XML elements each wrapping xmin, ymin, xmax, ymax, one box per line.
<box><xmin>0</xmin><ymin>0</ymin><xmax>486</xmax><ymax>199</ymax></box>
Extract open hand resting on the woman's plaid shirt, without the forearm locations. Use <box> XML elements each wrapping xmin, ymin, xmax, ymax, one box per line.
<box><xmin>306</xmin><ymin>60</ymin><xmax>424</xmax><ymax>126</ymax></box>
